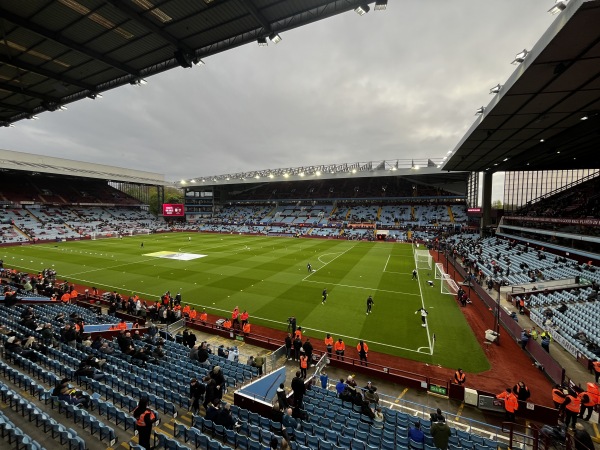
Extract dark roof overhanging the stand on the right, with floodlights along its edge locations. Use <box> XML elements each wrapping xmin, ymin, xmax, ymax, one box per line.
<box><xmin>443</xmin><ymin>0</ymin><xmax>600</xmax><ymax>172</ymax></box>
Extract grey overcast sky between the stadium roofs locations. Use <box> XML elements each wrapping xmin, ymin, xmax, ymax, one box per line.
<box><xmin>0</xmin><ymin>0</ymin><xmax>554</xmax><ymax>192</ymax></box>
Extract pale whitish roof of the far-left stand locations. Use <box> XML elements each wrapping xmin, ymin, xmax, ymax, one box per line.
<box><xmin>0</xmin><ymin>149</ymin><xmax>165</xmax><ymax>186</ymax></box>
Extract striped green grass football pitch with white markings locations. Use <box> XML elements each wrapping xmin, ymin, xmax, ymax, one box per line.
<box><xmin>0</xmin><ymin>233</ymin><xmax>489</xmax><ymax>373</ymax></box>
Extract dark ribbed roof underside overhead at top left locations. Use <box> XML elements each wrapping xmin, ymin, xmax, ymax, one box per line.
<box><xmin>0</xmin><ymin>0</ymin><xmax>387</xmax><ymax>126</ymax></box>
